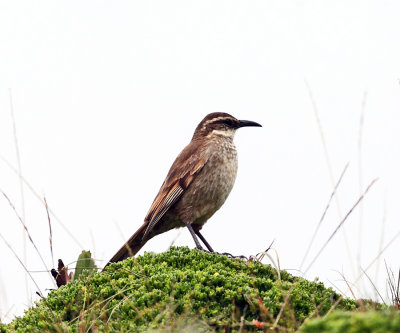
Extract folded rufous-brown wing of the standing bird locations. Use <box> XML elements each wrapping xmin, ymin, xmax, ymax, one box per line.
<box><xmin>143</xmin><ymin>145</ymin><xmax>207</xmax><ymax>238</ymax></box>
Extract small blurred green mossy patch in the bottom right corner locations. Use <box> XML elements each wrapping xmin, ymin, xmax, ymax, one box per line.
<box><xmin>301</xmin><ymin>310</ymin><xmax>400</xmax><ymax>333</ymax></box>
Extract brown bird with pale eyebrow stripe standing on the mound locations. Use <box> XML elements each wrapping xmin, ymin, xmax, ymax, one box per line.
<box><xmin>105</xmin><ymin>112</ymin><xmax>261</xmax><ymax>267</ymax></box>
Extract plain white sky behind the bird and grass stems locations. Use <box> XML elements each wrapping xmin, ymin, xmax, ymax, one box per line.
<box><xmin>0</xmin><ymin>0</ymin><xmax>400</xmax><ymax>321</ymax></box>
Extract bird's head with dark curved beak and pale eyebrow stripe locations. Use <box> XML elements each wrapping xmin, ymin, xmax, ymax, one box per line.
<box><xmin>193</xmin><ymin>112</ymin><xmax>261</xmax><ymax>139</ymax></box>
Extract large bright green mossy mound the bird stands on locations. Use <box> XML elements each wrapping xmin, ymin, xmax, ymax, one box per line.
<box><xmin>3</xmin><ymin>247</ymin><xmax>356</xmax><ymax>332</ymax></box>
